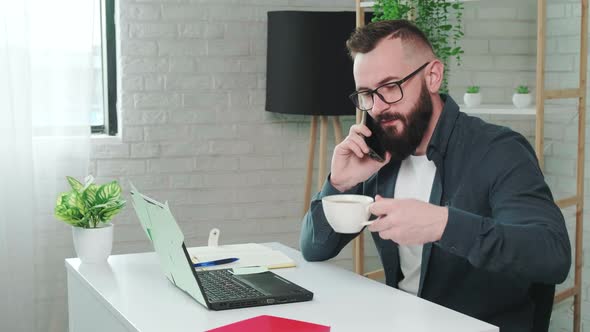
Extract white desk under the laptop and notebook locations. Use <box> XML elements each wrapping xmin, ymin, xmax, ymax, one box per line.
<box><xmin>66</xmin><ymin>243</ymin><xmax>498</xmax><ymax>332</ymax></box>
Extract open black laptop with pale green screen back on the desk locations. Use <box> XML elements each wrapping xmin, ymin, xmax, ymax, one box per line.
<box><xmin>131</xmin><ymin>185</ymin><xmax>313</xmax><ymax>310</ymax></box>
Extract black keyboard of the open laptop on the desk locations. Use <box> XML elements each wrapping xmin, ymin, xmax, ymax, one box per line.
<box><xmin>197</xmin><ymin>270</ymin><xmax>264</xmax><ymax>302</ymax></box>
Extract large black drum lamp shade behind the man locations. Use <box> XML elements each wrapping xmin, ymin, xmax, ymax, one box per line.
<box><xmin>266</xmin><ymin>11</ymin><xmax>366</xmax><ymax>115</ymax></box>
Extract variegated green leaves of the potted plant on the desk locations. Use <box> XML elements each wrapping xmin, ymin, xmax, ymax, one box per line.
<box><xmin>55</xmin><ymin>176</ymin><xmax>125</xmax><ymax>228</ymax></box>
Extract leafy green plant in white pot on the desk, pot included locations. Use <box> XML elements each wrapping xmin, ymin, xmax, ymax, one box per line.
<box><xmin>55</xmin><ymin>175</ymin><xmax>125</xmax><ymax>263</ymax></box>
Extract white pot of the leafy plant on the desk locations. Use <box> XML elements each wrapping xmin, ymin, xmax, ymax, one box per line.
<box><xmin>72</xmin><ymin>224</ymin><xmax>113</xmax><ymax>263</ymax></box>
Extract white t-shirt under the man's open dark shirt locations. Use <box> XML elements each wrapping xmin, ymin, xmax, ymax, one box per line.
<box><xmin>394</xmin><ymin>155</ymin><xmax>436</xmax><ymax>295</ymax></box>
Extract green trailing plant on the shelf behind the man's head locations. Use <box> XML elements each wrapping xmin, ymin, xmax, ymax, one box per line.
<box><xmin>372</xmin><ymin>0</ymin><xmax>464</xmax><ymax>92</ymax></box>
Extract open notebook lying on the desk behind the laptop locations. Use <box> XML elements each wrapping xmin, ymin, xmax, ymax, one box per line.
<box><xmin>188</xmin><ymin>243</ymin><xmax>295</xmax><ymax>270</ymax></box>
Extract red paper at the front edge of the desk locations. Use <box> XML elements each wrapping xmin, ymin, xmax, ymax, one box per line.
<box><xmin>207</xmin><ymin>315</ymin><xmax>330</xmax><ymax>332</ymax></box>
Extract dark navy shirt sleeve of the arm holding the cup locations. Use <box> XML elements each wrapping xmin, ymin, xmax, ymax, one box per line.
<box><xmin>437</xmin><ymin>134</ymin><xmax>571</xmax><ymax>284</ymax></box>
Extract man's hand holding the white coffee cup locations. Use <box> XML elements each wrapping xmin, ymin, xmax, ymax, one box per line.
<box><xmin>368</xmin><ymin>195</ymin><xmax>449</xmax><ymax>245</ymax></box>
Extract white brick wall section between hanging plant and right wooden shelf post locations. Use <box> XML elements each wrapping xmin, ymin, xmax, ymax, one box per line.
<box><xmin>449</xmin><ymin>0</ymin><xmax>536</xmax><ymax>104</ymax></box>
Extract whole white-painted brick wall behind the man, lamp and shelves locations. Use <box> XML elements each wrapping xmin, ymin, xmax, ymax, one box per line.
<box><xmin>36</xmin><ymin>0</ymin><xmax>590</xmax><ymax>331</ymax></box>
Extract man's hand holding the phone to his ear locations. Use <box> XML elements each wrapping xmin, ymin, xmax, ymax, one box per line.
<box><xmin>330</xmin><ymin>124</ymin><xmax>391</xmax><ymax>191</ymax></box>
